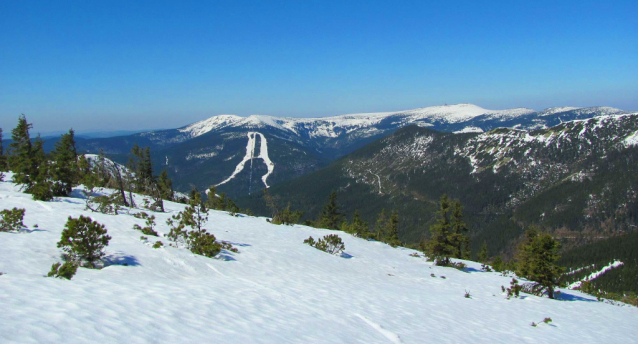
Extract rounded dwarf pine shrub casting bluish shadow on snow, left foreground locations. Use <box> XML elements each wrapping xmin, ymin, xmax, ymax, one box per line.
<box><xmin>58</xmin><ymin>215</ymin><xmax>111</xmax><ymax>268</ymax></box>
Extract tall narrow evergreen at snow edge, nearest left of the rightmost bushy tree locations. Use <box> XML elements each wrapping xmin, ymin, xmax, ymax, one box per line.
<box><xmin>427</xmin><ymin>195</ymin><xmax>457</xmax><ymax>265</ymax></box>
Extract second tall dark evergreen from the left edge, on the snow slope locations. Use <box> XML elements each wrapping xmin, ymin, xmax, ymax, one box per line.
<box><xmin>51</xmin><ymin>129</ymin><xmax>79</xmax><ymax>196</ymax></box>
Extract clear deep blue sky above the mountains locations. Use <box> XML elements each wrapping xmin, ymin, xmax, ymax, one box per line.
<box><xmin>0</xmin><ymin>0</ymin><xmax>638</xmax><ymax>134</ymax></box>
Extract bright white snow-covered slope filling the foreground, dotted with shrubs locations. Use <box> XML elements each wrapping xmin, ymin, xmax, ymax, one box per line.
<box><xmin>0</xmin><ymin>176</ymin><xmax>638</xmax><ymax>343</ymax></box>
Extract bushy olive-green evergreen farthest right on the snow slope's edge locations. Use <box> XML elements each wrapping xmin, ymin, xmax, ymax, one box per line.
<box><xmin>518</xmin><ymin>228</ymin><xmax>563</xmax><ymax>299</ymax></box>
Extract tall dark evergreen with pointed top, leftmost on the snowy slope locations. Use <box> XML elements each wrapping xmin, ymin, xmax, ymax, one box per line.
<box><xmin>9</xmin><ymin>115</ymin><xmax>36</xmax><ymax>189</ymax></box>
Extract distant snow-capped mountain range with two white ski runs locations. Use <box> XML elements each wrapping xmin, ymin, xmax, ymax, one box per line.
<box><xmin>72</xmin><ymin>104</ymin><xmax>626</xmax><ymax>197</ymax></box>
